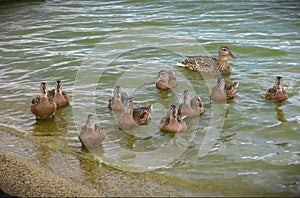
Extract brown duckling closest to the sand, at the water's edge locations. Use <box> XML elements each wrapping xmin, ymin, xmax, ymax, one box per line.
<box><xmin>78</xmin><ymin>114</ymin><xmax>105</xmax><ymax>149</ymax></box>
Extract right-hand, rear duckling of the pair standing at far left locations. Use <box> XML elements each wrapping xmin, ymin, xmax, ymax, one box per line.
<box><xmin>48</xmin><ymin>80</ymin><xmax>70</xmax><ymax>107</ymax></box>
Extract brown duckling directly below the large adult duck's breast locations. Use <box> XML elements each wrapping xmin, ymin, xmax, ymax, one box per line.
<box><xmin>210</xmin><ymin>76</ymin><xmax>239</xmax><ymax>101</ymax></box>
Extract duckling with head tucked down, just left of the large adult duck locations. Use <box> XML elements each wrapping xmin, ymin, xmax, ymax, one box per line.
<box><xmin>155</xmin><ymin>69</ymin><xmax>177</xmax><ymax>90</ymax></box>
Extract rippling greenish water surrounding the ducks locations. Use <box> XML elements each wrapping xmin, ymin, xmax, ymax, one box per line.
<box><xmin>0</xmin><ymin>0</ymin><xmax>300</xmax><ymax>196</ymax></box>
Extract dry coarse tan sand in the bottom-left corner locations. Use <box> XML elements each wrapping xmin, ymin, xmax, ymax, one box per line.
<box><xmin>0</xmin><ymin>150</ymin><xmax>100</xmax><ymax>197</ymax></box>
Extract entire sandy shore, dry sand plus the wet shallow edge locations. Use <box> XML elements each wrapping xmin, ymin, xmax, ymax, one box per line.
<box><xmin>0</xmin><ymin>128</ymin><xmax>202</xmax><ymax>197</ymax></box>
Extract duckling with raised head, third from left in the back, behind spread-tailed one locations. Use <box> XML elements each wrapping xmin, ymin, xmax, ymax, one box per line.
<box><xmin>108</xmin><ymin>86</ymin><xmax>129</xmax><ymax>111</ymax></box>
